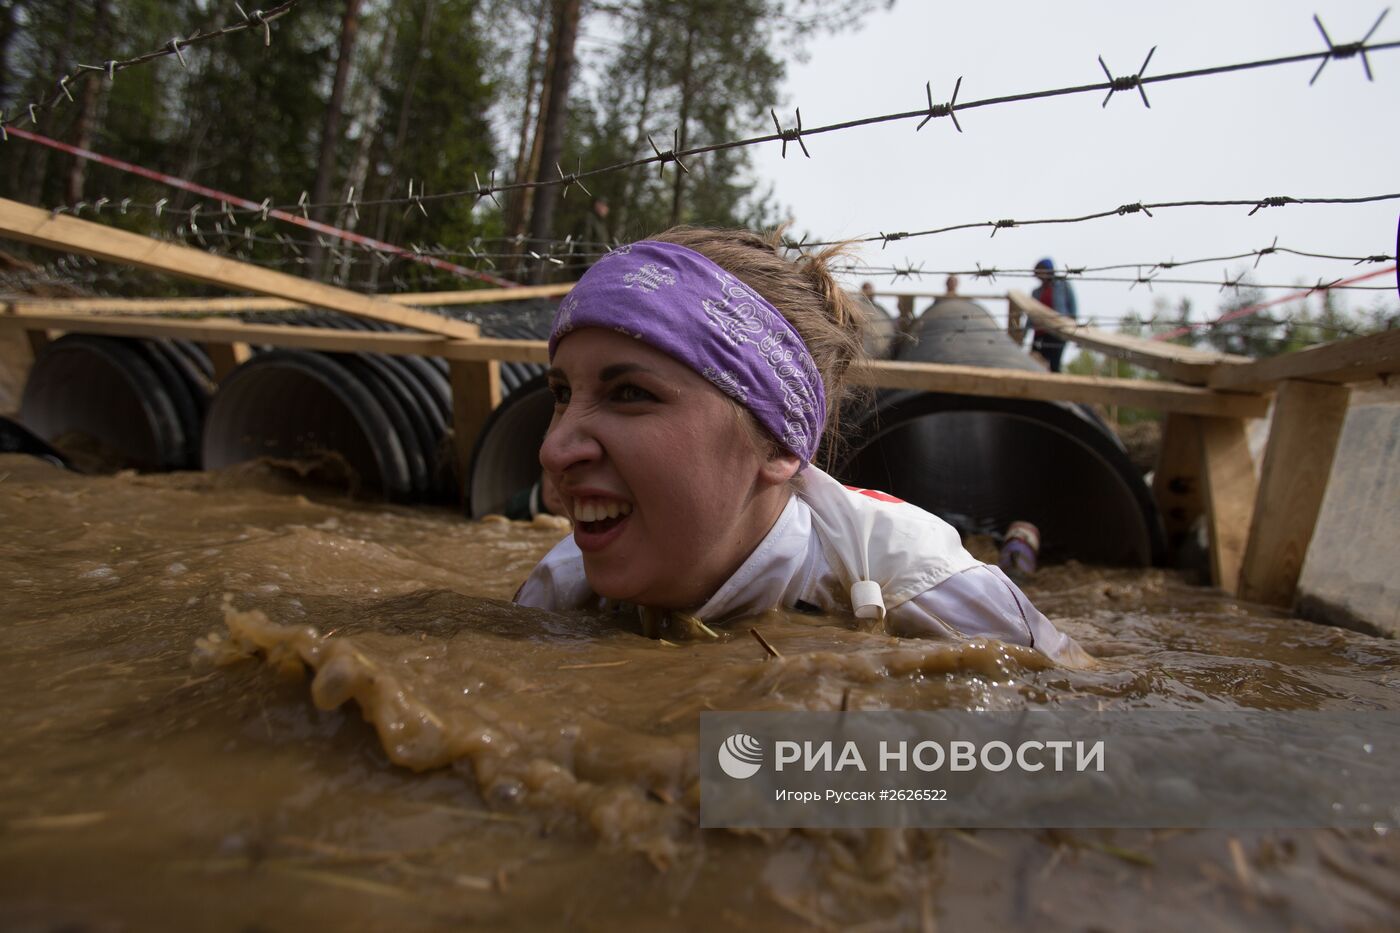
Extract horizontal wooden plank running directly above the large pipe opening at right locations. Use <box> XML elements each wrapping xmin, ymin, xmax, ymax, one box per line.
<box><xmin>851</xmin><ymin>360</ymin><xmax>1268</xmax><ymax>417</ymax></box>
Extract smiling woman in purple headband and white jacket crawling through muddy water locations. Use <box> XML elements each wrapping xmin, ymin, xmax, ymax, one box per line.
<box><xmin>515</xmin><ymin>227</ymin><xmax>1086</xmax><ymax>663</ymax></box>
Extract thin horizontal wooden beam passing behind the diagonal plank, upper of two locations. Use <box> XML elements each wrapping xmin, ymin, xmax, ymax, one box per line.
<box><xmin>13</xmin><ymin>282</ymin><xmax>574</xmax><ymax>315</ymax></box>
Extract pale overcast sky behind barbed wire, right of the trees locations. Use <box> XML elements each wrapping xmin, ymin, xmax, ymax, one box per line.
<box><xmin>755</xmin><ymin>0</ymin><xmax>1400</xmax><ymax>330</ymax></box>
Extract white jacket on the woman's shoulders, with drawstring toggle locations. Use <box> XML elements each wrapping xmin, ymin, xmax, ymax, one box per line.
<box><xmin>515</xmin><ymin>467</ymin><xmax>1088</xmax><ymax>664</ymax></box>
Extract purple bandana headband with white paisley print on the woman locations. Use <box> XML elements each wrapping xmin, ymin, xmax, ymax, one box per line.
<box><xmin>549</xmin><ymin>240</ymin><xmax>826</xmax><ymax>467</ymax></box>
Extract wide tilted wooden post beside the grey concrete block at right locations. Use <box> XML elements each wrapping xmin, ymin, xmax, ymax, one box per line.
<box><xmin>1239</xmin><ymin>380</ymin><xmax>1351</xmax><ymax>607</ymax></box>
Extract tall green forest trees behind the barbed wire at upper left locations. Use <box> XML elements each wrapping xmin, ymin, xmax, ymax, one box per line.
<box><xmin>0</xmin><ymin>0</ymin><xmax>889</xmax><ymax>294</ymax></box>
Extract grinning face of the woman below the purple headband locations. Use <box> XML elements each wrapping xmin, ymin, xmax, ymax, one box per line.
<box><xmin>539</xmin><ymin>328</ymin><xmax>798</xmax><ymax>608</ymax></box>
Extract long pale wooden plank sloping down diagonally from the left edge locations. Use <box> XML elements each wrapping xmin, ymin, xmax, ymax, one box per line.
<box><xmin>0</xmin><ymin>199</ymin><xmax>479</xmax><ymax>339</ymax></box>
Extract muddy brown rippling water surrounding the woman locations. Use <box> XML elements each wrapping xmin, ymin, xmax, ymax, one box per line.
<box><xmin>0</xmin><ymin>455</ymin><xmax>1400</xmax><ymax>930</ymax></box>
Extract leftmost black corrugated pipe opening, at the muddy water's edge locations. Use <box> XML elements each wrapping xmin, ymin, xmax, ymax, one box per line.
<box><xmin>20</xmin><ymin>333</ymin><xmax>213</xmax><ymax>471</ymax></box>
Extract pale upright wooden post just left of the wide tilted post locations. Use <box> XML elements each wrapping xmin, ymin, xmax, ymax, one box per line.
<box><xmin>1197</xmin><ymin>417</ymin><xmax>1257</xmax><ymax>593</ymax></box>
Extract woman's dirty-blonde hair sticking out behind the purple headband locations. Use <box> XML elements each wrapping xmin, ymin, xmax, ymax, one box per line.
<box><xmin>648</xmin><ymin>226</ymin><xmax>867</xmax><ymax>465</ymax></box>
